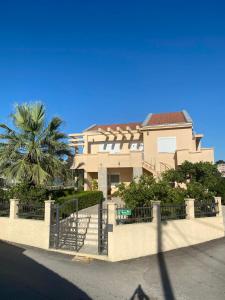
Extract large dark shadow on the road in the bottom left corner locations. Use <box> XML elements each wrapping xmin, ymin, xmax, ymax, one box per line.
<box><xmin>0</xmin><ymin>242</ymin><xmax>91</xmax><ymax>300</ymax></box>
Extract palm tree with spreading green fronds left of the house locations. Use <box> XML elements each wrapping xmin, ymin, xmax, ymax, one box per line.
<box><xmin>0</xmin><ymin>103</ymin><xmax>71</xmax><ymax>186</ymax></box>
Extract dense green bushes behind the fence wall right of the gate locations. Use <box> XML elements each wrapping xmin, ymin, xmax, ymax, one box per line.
<box><xmin>118</xmin><ymin>161</ymin><xmax>225</xmax><ymax>208</ymax></box>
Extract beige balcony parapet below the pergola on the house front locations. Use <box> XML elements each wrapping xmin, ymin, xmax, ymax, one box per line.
<box><xmin>72</xmin><ymin>151</ymin><xmax>143</xmax><ymax>172</ymax></box>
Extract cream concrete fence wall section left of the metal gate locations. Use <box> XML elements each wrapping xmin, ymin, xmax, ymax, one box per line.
<box><xmin>0</xmin><ymin>199</ymin><xmax>52</xmax><ymax>249</ymax></box>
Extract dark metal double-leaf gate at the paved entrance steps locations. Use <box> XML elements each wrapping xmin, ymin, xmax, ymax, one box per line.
<box><xmin>50</xmin><ymin>200</ymin><xmax>108</xmax><ymax>255</ymax></box>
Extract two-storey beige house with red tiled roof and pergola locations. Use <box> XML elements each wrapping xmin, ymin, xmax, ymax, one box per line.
<box><xmin>70</xmin><ymin>111</ymin><xmax>214</xmax><ymax>196</ymax></box>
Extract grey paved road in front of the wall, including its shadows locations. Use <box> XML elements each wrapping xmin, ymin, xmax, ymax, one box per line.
<box><xmin>0</xmin><ymin>238</ymin><xmax>225</xmax><ymax>300</ymax></box>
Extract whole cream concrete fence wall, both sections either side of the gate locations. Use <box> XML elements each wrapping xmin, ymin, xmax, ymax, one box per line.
<box><xmin>0</xmin><ymin>197</ymin><xmax>224</xmax><ymax>261</ymax></box>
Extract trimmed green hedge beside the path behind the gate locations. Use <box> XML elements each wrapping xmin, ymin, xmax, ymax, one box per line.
<box><xmin>55</xmin><ymin>191</ymin><xmax>103</xmax><ymax>210</ymax></box>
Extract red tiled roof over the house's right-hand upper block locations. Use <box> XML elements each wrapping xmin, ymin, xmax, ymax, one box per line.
<box><xmin>147</xmin><ymin>112</ymin><xmax>188</xmax><ymax>126</ymax></box>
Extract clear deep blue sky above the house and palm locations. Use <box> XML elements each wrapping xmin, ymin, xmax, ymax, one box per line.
<box><xmin>0</xmin><ymin>0</ymin><xmax>225</xmax><ymax>159</ymax></box>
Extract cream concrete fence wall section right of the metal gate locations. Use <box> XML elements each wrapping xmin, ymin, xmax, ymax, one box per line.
<box><xmin>108</xmin><ymin>197</ymin><xmax>224</xmax><ymax>261</ymax></box>
